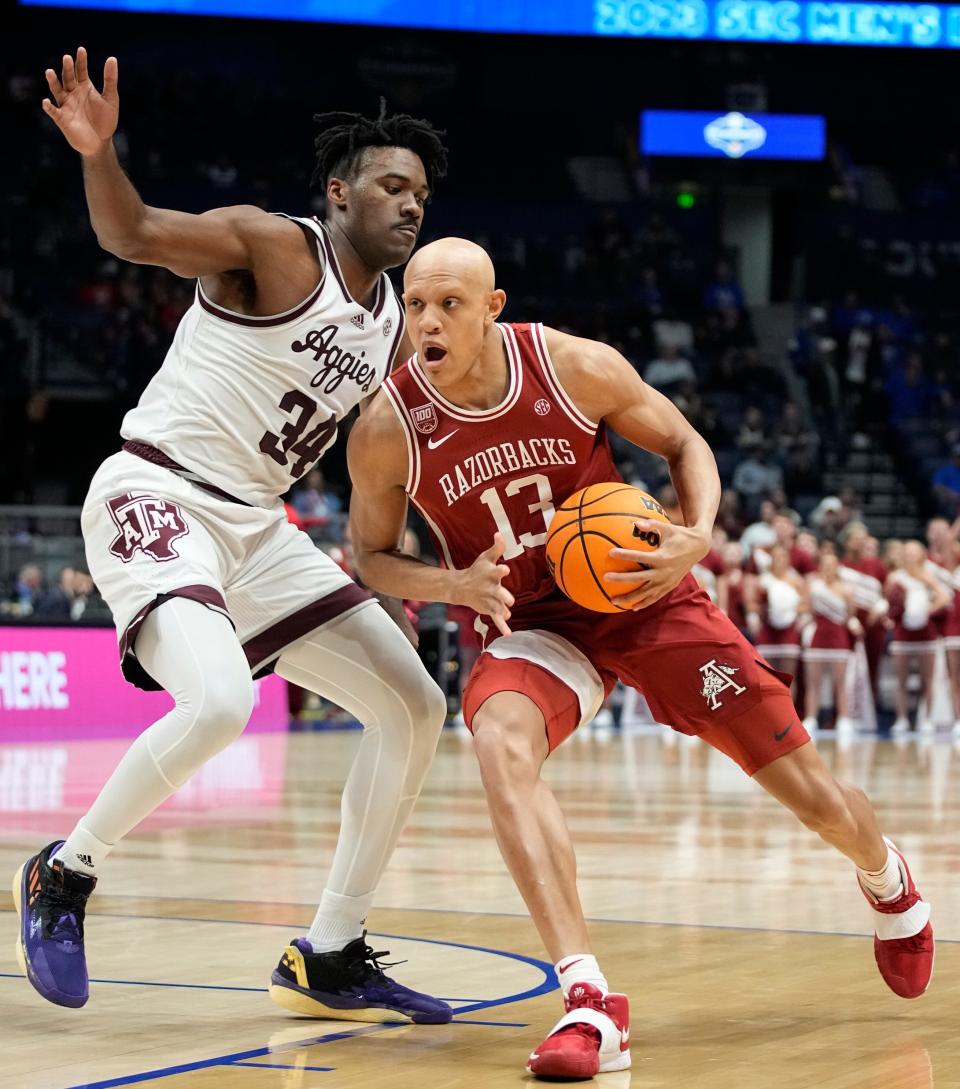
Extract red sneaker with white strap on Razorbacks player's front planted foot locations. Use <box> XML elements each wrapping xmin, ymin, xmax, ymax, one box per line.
<box><xmin>527</xmin><ymin>983</ymin><xmax>630</xmax><ymax>1079</ymax></box>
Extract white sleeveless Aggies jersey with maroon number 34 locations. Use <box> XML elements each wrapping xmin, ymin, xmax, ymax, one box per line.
<box><xmin>121</xmin><ymin>217</ymin><xmax>404</xmax><ymax>506</ymax></box>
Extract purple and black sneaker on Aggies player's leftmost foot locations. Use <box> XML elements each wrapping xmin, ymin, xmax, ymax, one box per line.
<box><xmin>13</xmin><ymin>840</ymin><xmax>97</xmax><ymax>1006</ymax></box>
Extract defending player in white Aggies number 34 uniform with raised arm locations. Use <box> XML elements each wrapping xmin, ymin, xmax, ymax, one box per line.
<box><xmin>14</xmin><ymin>49</ymin><xmax>452</xmax><ymax>1023</ymax></box>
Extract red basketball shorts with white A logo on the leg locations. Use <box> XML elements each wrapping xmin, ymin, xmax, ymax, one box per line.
<box><xmin>464</xmin><ymin>578</ymin><xmax>810</xmax><ymax>775</ymax></box>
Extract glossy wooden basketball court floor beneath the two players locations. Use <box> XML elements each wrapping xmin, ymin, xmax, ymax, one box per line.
<box><xmin>0</xmin><ymin>731</ymin><xmax>960</xmax><ymax>1089</ymax></box>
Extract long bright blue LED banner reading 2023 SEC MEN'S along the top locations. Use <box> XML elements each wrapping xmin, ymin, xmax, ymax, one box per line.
<box><xmin>21</xmin><ymin>0</ymin><xmax>960</xmax><ymax>49</ymax></box>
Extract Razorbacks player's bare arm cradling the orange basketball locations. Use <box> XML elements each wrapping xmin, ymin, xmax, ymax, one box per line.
<box><xmin>546</xmin><ymin>329</ymin><xmax>721</xmax><ymax>609</ymax></box>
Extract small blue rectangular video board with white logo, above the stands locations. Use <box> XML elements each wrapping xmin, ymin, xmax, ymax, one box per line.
<box><xmin>640</xmin><ymin>110</ymin><xmax>826</xmax><ymax>160</ymax></box>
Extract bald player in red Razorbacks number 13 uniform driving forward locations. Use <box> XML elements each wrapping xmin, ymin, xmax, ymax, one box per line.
<box><xmin>348</xmin><ymin>238</ymin><xmax>933</xmax><ymax>1078</ymax></box>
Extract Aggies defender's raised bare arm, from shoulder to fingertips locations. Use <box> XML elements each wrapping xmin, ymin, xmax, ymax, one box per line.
<box><xmin>44</xmin><ymin>46</ymin><xmax>303</xmax><ymax>277</ymax></box>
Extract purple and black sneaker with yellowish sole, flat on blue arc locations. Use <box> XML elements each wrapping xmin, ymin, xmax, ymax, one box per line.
<box><xmin>270</xmin><ymin>930</ymin><xmax>453</xmax><ymax>1025</ymax></box>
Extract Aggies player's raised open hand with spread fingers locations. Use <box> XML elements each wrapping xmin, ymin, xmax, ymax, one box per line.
<box><xmin>44</xmin><ymin>46</ymin><xmax>120</xmax><ymax>155</ymax></box>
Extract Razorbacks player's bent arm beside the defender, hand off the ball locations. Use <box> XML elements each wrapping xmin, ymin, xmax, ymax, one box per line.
<box><xmin>347</xmin><ymin>393</ymin><xmax>514</xmax><ymax>635</ymax></box>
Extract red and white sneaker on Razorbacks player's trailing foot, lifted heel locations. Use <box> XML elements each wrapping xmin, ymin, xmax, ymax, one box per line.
<box><xmin>860</xmin><ymin>836</ymin><xmax>935</xmax><ymax>999</ymax></box>
